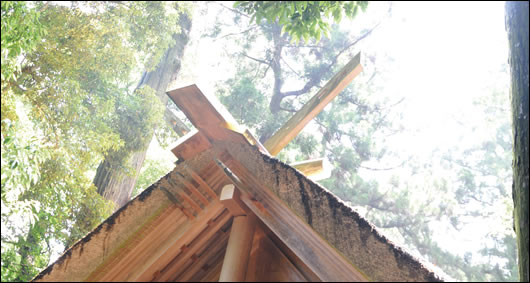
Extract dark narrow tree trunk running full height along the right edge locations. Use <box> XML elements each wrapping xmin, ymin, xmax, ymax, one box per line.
<box><xmin>506</xmin><ymin>2</ymin><xmax>530</xmax><ymax>282</ymax></box>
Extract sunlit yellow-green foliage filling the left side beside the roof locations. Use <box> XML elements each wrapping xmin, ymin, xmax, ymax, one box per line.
<box><xmin>1</xmin><ymin>1</ymin><xmax>187</xmax><ymax>281</ymax></box>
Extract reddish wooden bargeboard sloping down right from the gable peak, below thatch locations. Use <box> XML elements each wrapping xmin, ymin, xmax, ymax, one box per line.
<box><xmin>217</xmin><ymin>159</ymin><xmax>368</xmax><ymax>281</ymax></box>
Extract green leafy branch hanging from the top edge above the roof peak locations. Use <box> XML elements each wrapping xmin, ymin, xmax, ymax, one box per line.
<box><xmin>234</xmin><ymin>1</ymin><xmax>368</xmax><ymax>41</ymax></box>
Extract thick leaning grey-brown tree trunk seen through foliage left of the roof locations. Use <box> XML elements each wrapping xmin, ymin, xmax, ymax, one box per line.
<box><xmin>94</xmin><ymin>13</ymin><xmax>191</xmax><ymax>209</ymax></box>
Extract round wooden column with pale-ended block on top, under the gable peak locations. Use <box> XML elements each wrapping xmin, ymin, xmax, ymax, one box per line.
<box><xmin>219</xmin><ymin>185</ymin><xmax>256</xmax><ymax>282</ymax></box>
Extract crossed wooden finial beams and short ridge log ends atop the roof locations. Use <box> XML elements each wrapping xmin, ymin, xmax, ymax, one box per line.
<box><xmin>168</xmin><ymin>53</ymin><xmax>362</xmax><ymax>177</ymax></box>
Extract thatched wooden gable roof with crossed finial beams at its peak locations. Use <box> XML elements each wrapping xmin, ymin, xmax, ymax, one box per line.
<box><xmin>33</xmin><ymin>52</ymin><xmax>441</xmax><ymax>281</ymax></box>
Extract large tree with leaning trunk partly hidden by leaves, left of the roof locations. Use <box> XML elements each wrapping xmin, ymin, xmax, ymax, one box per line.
<box><xmin>94</xmin><ymin>4</ymin><xmax>191</xmax><ymax>209</ymax></box>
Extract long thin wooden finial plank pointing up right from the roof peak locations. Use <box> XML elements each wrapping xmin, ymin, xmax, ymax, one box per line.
<box><xmin>264</xmin><ymin>52</ymin><xmax>362</xmax><ymax>156</ymax></box>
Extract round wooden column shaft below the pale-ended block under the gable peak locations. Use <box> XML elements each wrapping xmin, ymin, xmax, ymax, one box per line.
<box><xmin>219</xmin><ymin>215</ymin><xmax>256</xmax><ymax>282</ymax></box>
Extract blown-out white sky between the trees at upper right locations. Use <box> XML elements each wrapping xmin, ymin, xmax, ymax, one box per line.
<box><xmin>346</xmin><ymin>2</ymin><xmax>508</xmax><ymax>272</ymax></box>
